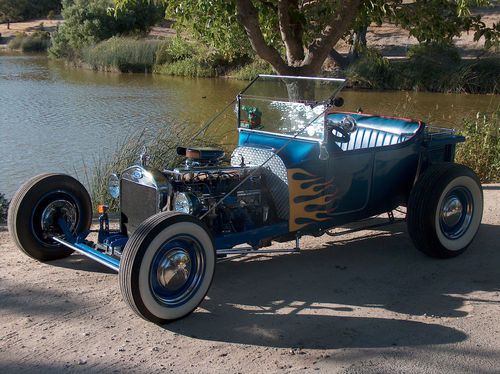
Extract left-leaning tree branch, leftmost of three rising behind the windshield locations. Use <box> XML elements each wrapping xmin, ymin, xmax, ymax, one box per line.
<box><xmin>236</xmin><ymin>0</ymin><xmax>290</xmax><ymax>74</ymax></box>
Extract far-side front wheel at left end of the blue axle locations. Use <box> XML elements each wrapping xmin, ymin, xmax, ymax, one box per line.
<box><xmin>7</xmin><ymin>174</ymin><xmax>92</xmax><ymax>261</ymax></box>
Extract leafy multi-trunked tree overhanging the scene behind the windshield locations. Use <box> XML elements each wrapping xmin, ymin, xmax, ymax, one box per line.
<box><xmin>116</xmin><ymin>0</ymin><xmax>498</xmax><ymax>75</ymax></box>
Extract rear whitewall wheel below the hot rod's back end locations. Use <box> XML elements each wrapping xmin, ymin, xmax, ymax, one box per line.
<box><xmin>407</xmin><ymin>163</ymin><xmax>483</xmax><ymax>258</ymax></box>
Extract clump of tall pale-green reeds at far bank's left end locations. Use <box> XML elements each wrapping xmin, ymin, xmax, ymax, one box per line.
<box><xmin>81</xmin><ymin>37</ymin><xmax>160</xmax><ymax>73</ymax></box>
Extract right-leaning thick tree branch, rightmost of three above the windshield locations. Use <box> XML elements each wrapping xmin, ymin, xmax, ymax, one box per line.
<box><xmin>302</xmin><ymin>0</ymin><xmax>362</xmax><ymax>74</ymax></box>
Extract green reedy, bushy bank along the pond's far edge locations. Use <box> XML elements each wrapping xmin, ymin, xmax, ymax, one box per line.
<box><xmin>81</xmin><ymin>37</ymin><xmax>500</xmax><ymax>94</ymax></box>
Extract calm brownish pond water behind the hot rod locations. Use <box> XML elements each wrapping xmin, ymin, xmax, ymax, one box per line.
<box><xmin>0</xmin><ymin>54</ymin><xmax>500</xmax><ymax>197</ymax></box>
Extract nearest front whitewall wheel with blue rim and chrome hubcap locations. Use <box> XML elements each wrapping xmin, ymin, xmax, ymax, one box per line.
<box><xmin>119</xmin><ymin>212</ymin><xmax>216</xmax><ymax>324</ymax></box>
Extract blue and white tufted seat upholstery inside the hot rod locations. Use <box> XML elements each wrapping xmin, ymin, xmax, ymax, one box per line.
<box><xmin>328</xmin><ymin>113</ymin><xmax>420</xmax><ymax>151</ymax></box>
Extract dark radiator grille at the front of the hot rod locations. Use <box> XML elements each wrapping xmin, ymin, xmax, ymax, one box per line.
<box><xmin>120</xmin><ymin>179</ymin><xmax>159</xmax><ymax>235</ymax></box>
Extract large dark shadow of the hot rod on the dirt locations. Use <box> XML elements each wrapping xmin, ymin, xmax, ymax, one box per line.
<box><xmin>164</xmin><ymin>223</ymin><xmax>500</xmax><ymax>349</ymax></box>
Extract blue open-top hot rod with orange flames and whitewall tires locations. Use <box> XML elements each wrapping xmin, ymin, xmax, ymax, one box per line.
<box><xmin>8</xmin><ymin>76</ymin><xmax>483</xmax><ymax>323</ymax></box>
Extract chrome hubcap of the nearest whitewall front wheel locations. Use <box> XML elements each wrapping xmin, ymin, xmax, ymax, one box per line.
<box><xmin>156</xmin><ymin>248</ymin><xmax>191</xmax><ymax>291</ymax></box>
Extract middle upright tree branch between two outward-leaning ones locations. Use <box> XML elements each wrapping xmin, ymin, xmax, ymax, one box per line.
<box><xmin>278</xmin><ymin>0</ymin><xmax>304</xmax><ymax>66</ymax></box>
